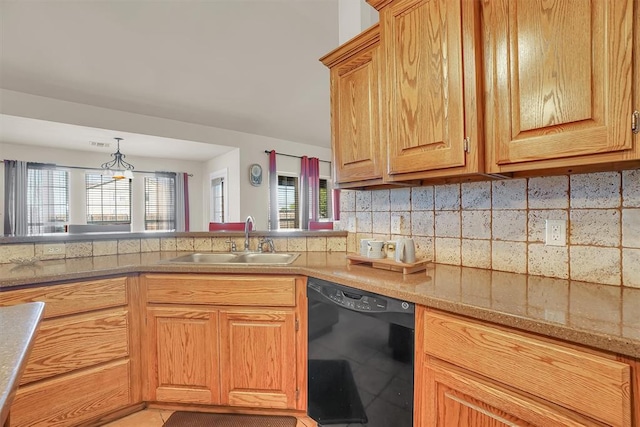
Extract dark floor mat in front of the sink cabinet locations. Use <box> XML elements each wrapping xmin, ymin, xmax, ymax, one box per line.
<box><xmin>163</xmin><ymin>411</ymin><xmax>298</xmax><ymax>427</ymax></box>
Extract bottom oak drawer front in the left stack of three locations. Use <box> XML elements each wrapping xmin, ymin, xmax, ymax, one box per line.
<box><xmin>11</xmin><ymin>361</ymin><xmax>131</xmax><ymax>427</ymax></box>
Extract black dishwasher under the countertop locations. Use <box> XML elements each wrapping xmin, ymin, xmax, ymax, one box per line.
<box><xmin>307</xmin><ymin>278</ymin><xmax>415</xmax><ymax>427</ymax></box>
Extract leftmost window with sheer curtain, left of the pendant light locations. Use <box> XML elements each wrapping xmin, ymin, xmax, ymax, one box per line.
<box><xmin>27</xmin><ymin>163</ymin><xmax>69</xmax><ymax>234</ymax></box>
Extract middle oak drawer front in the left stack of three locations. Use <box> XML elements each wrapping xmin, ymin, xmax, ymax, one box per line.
<box><xmin>20</xmin><ymin>309</ymin><xmax>129</xmax><ymax>384</ymax></box>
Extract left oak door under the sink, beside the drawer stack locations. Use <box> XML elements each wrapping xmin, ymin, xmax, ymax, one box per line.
<box><xmin>147</xmin><ymin>307</ymin><xmax>220</xmax><ymax>404</ymax></box>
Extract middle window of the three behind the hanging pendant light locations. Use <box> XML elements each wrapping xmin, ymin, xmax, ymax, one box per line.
<box><xmin>85</xmin><ymin>173</ymin><xmax>131</xmax><ymax>224</ymax></box>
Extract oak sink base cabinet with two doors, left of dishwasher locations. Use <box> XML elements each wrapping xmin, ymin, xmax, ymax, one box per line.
<box><xmin>141</xmin><ymin>274</ymin><xmax>306</xmax><ymax>410</ymax></box>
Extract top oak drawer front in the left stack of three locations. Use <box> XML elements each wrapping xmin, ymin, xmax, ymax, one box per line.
<box><xmin>0</xmin><ymin>277</ymin><xmax>127</xmax><ymax>319</ymax></box>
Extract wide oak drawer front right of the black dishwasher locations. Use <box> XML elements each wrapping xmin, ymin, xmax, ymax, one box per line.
<box><xmin>423</xmin><ymin>312</ymin><xmax>631</xmax><ymax>426</ymax></box>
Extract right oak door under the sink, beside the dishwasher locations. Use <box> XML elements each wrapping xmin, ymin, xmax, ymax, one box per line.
<box><xmin>220</xmin><ymin>309</ymin><xmax>298</xmax><ymax>409</ymax></box>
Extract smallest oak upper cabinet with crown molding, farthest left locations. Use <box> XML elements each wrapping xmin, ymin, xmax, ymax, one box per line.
<box><xmin>320</xmin><ymin>25</ymin><xmax>383</xmax><ymax>187</ymax></box>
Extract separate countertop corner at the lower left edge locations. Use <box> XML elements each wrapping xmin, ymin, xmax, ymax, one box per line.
<box><xmin>0</xmin><ymin>302</ymin><xmax>44</xmax><ymax>425</ymax></box>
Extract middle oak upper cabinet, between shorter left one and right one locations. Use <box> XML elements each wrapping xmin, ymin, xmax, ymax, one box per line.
<box><xmin>374</xmin><ymin>0</ymin><xmax>483</xmax><ymax>181</ymax></box>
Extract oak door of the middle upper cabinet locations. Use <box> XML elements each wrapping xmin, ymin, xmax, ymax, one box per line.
<box><xmin>380</xmin><ymin>0</ymin><xmax>465</xmax><ymax>180</ymax></box>
